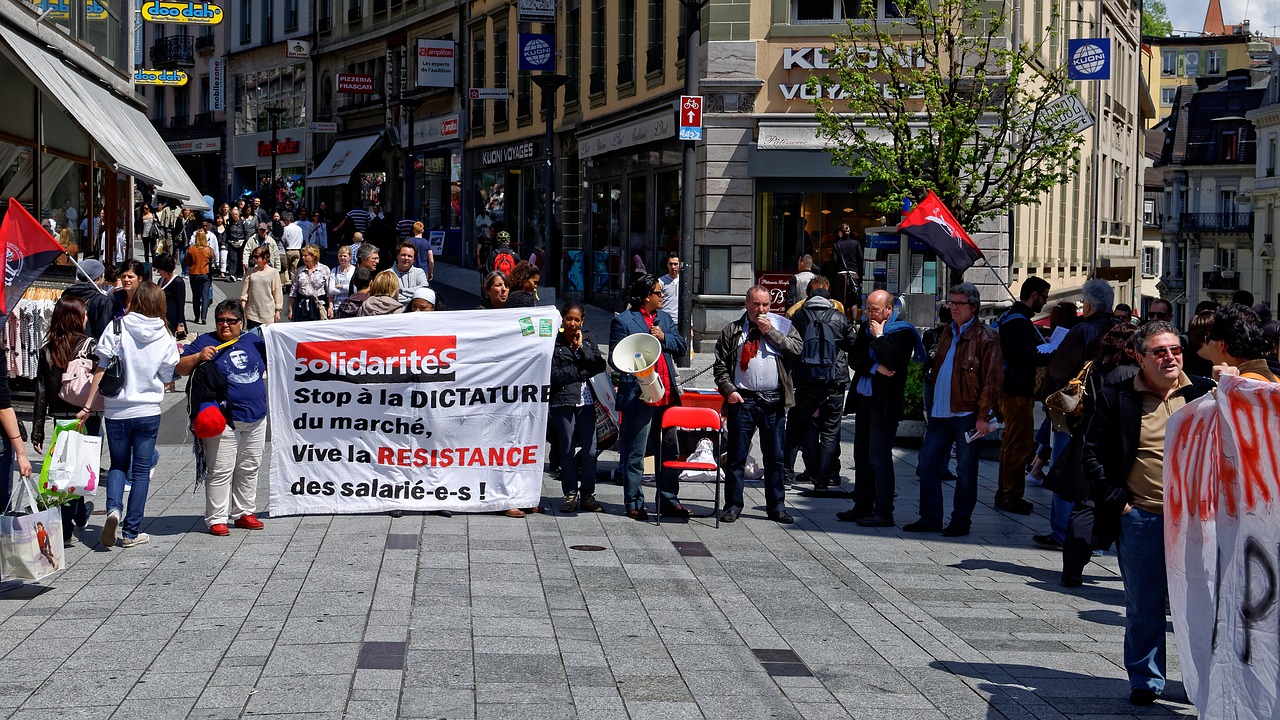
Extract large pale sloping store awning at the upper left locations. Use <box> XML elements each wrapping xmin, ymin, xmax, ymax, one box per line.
<box><xmin>0</xmin><ymin>27</ymin><xmax>211</xmax><ymax>210</ymax></box>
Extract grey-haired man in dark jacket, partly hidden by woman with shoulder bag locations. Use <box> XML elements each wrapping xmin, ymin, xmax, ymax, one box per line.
<box><xmin>1032</xmin><ymin>279</ymin><xmax>1116</xmax><ymax>550</ymax></box>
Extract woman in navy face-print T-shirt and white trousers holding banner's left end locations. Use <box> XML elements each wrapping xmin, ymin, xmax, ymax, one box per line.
<box><xmin>178</xmin><ymin>300</ymin><xmax>266</xmax><ymax>537</ymax></box>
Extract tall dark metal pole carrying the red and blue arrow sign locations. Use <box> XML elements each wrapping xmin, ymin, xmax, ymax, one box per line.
<box><xmin>676</xmin><ymin>0</ymin><xmax>707</xmax><ymax>368</ymax></box>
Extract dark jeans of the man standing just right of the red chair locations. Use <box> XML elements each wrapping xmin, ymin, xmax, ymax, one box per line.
<box><xmin>724</xmin><ymin>396</ymin><xmax>786</xmax><ymax>512</ymax></box>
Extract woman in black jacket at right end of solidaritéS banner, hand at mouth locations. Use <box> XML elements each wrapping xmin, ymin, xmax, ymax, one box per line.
<box><xmin>549</xmin><ymin>302</ymin><xmax>605</xmax><ymax>512</ymax></box>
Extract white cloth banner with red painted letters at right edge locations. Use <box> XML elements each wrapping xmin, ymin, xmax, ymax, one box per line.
<box><xmin>1165</xmin><ymin>375</ymin><xmax>1280</xmax><ymax>720</ymax></box>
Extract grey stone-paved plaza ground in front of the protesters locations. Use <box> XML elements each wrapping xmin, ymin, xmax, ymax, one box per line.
<box><xmin>0</xmin><ymin>428</ymin><xmax>1194</xmax><ymax>720</ymax></box>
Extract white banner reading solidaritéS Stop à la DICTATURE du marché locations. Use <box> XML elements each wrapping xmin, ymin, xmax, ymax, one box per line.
<box><xmin>265</xmin><ymin>307</ymin><xmax>561</xmax><ymax>516</ymax></box>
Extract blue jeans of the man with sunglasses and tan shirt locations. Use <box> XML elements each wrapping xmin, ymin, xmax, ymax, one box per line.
<box><xmin>1116</xmin><ymin>507</ymin><xmax>1169</xmax><ymax>694</ymax></box>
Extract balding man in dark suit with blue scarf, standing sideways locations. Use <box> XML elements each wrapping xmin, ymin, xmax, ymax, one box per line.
<box><xmin>836</xmin><ymin>290</ymin><xmax>924</xmax><ymax>528</ymax></box>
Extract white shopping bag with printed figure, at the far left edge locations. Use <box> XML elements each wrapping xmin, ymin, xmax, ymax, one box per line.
<box><xmin>0</xmin><ymin>478</ymin><xmax>64</xmax><ymax>580</ymax></box>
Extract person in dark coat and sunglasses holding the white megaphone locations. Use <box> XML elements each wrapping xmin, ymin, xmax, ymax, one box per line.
<box><xmin>609</xmin><ymin>274</ymin><xmax>690</xmax><ymax>520</ymax></box>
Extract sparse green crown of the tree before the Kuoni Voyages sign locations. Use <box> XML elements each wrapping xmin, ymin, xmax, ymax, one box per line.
<box><xmin>809</xmin><ymin>0</ymin><xmax>1080</xmax><ymax>229</ymax></box>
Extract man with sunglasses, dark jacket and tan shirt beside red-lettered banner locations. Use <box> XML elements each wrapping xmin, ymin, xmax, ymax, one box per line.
<box><xmin>1083</xmin><ymin>320</ymin><xmax>1213</xmax><ymax>705</ymax></box>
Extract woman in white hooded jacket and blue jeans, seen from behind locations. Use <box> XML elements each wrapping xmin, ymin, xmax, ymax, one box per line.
<box><xmin>78</xmin><ymin>282</ymin><xmax>178</xmax><ymax>547</ymax></box>
